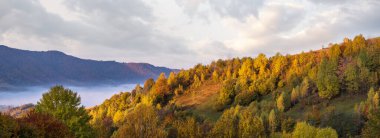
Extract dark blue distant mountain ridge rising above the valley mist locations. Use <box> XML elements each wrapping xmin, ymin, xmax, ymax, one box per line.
<box><xmin>0</xmin><ymin>45</ymin><xmax>175</xmax><ymax>90</ymax></box>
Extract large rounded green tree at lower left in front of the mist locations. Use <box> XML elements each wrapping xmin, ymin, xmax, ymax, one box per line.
<box><xmin>35</xmin><ymin>86</ymin><xmax>93</xmax><ymax>137</ymax></box>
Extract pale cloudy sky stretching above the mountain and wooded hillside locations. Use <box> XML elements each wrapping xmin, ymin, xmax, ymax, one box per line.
<box><xmin>0</xmin><ymin>0</ymin><xmax>380</xmax><ymax>68</ymax></box>
